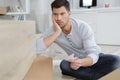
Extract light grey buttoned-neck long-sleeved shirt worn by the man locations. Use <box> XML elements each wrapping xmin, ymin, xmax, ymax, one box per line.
<box><xmin>36</xmin><ymin>18</ymin><xmax>100</xmax><ymax>64</ymax></box>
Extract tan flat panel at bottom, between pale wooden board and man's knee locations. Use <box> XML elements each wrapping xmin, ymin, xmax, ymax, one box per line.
<box><xmin>24</xmin><ymin>55</ymin><xmax>53</xmax><ymax>80</ymax></box>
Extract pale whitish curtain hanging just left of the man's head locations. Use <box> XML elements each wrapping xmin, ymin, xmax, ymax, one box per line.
<box><xmin>27</xmin><ymin>0</ymin><xmax>51</xmax><ymax>33</ymax></box>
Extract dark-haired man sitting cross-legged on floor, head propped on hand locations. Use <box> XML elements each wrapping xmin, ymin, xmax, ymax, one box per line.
<box><xmin>37</xmin><ymin>0</ymin><xmax>120</xmax><ymax>80</ymax></box>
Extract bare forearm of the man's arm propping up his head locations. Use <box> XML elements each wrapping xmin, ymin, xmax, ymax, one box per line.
<box><xmin>44</xmin><ymin>31</ymin><xmax>61</xmax><ymax>48</ymax></box>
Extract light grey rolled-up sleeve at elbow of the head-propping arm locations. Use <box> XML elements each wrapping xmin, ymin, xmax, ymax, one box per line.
<box><xmin>36</xmin><ymin>38</ymin><xmax>46</xmax><ymax>54</ymax></box>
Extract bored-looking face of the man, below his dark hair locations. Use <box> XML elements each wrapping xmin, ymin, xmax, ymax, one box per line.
<box><xmin>52</xmin><ymin>6</ymin><xmax>70</xmax><ymax>28</ymax></box>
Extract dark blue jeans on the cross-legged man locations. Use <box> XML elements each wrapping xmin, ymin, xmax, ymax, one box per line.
<box><xmin>60</xmin><ymin>53</ymin><xmax>120</xmax><ymax>80</ymax></box>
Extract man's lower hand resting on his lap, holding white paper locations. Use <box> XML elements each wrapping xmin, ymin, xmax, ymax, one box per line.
<box><xmin>69</xmin><ymin>57</ymin><xmax>82</xmax><ymax>70</ymax></box>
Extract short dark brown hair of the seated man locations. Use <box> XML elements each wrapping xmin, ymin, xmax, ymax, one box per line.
<box><xmin>51</xmin><ymin>0</ymin><xmax>70</xmax><ymax>11</ymax></box>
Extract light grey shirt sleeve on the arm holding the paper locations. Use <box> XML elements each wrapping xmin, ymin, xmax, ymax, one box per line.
<box><xmin>82</xmin><ymin>22</ymin><xmax>101</xmax><ymax>64</ymax></box>
